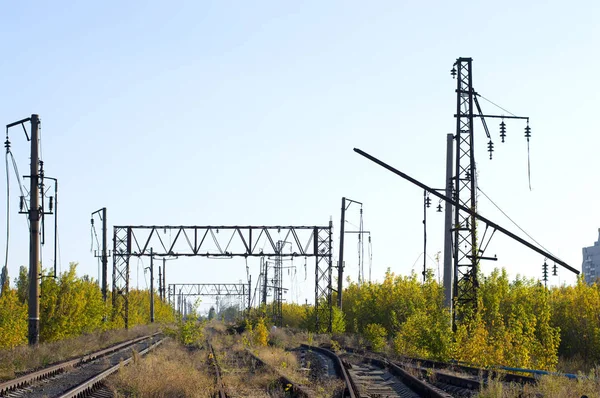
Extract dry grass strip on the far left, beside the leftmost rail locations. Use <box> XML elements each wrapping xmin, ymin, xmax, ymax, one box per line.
<box><xmin>0</xmin><ymin>325</ymin><xmax>158</xmax><ymax>380</ymax></box>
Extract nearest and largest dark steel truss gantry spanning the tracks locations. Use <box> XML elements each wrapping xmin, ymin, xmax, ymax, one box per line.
<box><xmin>112</xmin><ymin>225</ymin><xmax>333</xmax><ymax>332</ymax></box>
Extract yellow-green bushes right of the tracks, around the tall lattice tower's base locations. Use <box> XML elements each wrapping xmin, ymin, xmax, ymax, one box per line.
<box><xmin>343</xmin><ymin>270</ymin><xmax>600</xmax><ymax>370</ymax></box>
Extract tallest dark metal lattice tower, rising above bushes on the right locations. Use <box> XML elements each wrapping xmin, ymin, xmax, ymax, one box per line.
<box><xmin>453</xmin><ymin>58</ymin><xmax>479</xmax><ymax>314</ymax></box>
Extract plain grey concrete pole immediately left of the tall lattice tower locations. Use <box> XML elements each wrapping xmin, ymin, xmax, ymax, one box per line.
<box><xmin>444</xmin><ymin>134</ymin><xmax>454</xmax><ymax>323</ymax></box>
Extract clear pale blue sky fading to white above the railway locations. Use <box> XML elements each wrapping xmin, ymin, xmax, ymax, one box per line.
<box><xmin>0</xmin><ymin>1</ymin><xmax>600</xmax><ymax>310</ymax></box>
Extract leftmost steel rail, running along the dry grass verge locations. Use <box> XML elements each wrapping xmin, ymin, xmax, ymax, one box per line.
<box><xmin>0</xmin><ymin>333</ymin><xmax>158</xmax><ymax>396</ymax></box>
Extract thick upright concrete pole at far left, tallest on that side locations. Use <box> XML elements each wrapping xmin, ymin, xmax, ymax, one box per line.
<box><xmin>28</xmin><ymin>115</ymin><xmax>40</xmax><ymax>345</ymax></box>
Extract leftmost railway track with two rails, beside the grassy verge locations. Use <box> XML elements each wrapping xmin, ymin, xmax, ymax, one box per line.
<box><xmin>0</xmin><ymin>334</ymin><xmax>163</xmax><ymax>398</ymax></box>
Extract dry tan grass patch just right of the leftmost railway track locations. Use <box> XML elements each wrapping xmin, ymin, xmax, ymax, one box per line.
<box><xmin>108</xmin><ymin>340</ymin><xmax>215</xmax><ymax>398</ymax></box>
